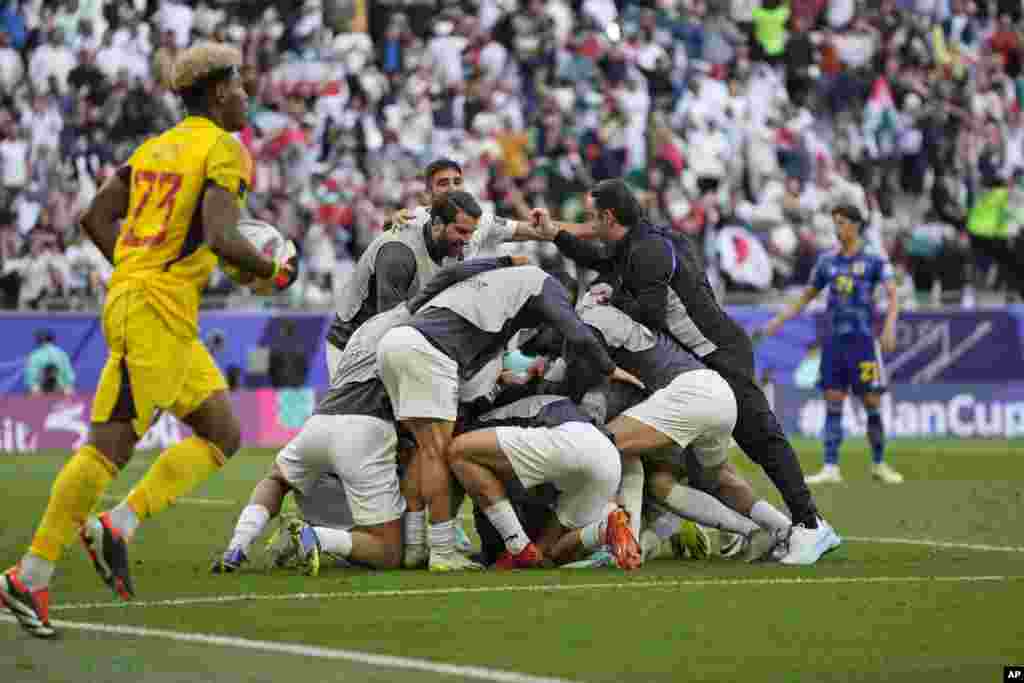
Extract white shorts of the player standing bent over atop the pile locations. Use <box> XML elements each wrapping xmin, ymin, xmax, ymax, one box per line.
<box><xmin>377</xmin><ymin>326</ymin><xmax>459</xmax><ymax>422</ymax></box>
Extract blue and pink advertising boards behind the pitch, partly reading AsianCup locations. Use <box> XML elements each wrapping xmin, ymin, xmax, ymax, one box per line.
<box><xmin>0</xmin><ymin>306</ymin><xmax>1024</xmax><ymax>453</ymax></box>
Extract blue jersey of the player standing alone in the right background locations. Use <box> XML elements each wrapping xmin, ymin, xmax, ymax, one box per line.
<box><xmin>810</xmin><ymin>247</ymin><xmax>893</xmax><ymax>337</ymax></box>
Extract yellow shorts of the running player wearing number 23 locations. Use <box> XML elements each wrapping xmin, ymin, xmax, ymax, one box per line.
<box><xmin>92</xmin><ymin>290</ymin><xmax>227</xmax><ymax>437</ymax></box>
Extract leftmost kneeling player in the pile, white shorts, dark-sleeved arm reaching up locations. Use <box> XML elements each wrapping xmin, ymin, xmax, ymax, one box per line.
<box><xmin>212</xmin><ymin>257</ymin><xmax>525</xmax><ymax>573</ymax></box>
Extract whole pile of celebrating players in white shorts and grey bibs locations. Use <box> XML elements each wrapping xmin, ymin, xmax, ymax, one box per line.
<box><xmin>213</xmin><ymin>160</ymin><xmax>841</xmax><ymax>573</ymax></box>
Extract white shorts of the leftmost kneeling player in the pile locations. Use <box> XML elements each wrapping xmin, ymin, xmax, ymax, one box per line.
<box><xmin>276</xmin><ymin>415</ymin><xmax>406</xmax><ymax>526</ymax></box>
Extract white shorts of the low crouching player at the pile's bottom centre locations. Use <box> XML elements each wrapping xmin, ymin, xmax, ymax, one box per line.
<box><xmin>495</xmin><ymin>422</ymin><xmax>623</xmax><ymax>528</ymax></box>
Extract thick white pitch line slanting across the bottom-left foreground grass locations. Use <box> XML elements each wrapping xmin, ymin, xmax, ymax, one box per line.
<box><xmin>0</xmin><ymin>614</ymin><xmax>572</xmax><ymax>683</ymax></box>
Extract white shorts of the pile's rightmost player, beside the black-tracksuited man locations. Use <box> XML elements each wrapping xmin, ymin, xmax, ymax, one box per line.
<box><xmin>623</xmin><ymin>370</ymin><xmax>736</xmax><ymax>467</ymax></box>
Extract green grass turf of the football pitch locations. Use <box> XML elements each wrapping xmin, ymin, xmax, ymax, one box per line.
<box><xmin>0</xmin><ymin>440</ymin><xmax>1024</xmax><ymax>683</ymax></box>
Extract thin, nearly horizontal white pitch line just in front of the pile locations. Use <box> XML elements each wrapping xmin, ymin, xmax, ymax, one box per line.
<box><xmin>50</xmin><ymin>575</ymin><xmax>1024</xmax><ymax>611</ymax></box>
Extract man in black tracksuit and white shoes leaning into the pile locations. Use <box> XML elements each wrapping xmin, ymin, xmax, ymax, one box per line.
<box><xmin>540</xmin><ymin>179</ymin><xmax>838</xmax><ymax>564</ymax></box>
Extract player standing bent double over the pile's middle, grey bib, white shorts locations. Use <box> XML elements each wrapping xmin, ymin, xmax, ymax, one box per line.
<box><xmin>378</xmin><ymin>224</ymin><xmax>642</xmax><ymax>571</ymax></box>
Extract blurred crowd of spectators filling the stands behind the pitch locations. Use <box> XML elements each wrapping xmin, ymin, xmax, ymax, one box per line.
<box><xmin>0</xmin><ymin>0</ymin><xmax>1024</xmax><ymax>309</ymax></box>
